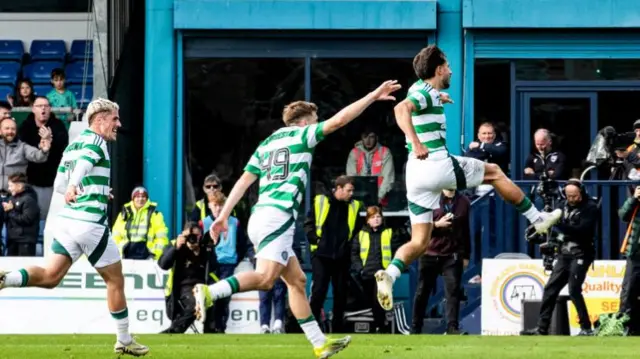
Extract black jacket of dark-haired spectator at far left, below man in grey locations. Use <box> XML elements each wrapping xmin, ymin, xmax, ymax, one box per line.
<box><xmin>5</xmin><ymin>185</ymin><xmax>40</xmax><ymax>243</ymax></box>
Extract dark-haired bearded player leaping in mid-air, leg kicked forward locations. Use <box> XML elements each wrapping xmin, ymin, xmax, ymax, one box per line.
<box><xmin>375</xmin><ymin>46</ymin><xmax>562</xmax><ymax>310</ymax></box>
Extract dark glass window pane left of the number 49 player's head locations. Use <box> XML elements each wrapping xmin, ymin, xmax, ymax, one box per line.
<box><xmin>184</xmin><ymin>58</ymin><xmax>304</xmax><ymax>223</ymax></box>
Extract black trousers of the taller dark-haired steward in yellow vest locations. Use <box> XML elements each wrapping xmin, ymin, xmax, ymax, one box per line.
<box><xmin>310</xmin><ymin>256</ymin><xmax>351</xmax><ymax>333</ymax></box>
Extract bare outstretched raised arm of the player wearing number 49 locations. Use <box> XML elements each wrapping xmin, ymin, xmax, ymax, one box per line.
<box><xmin>322</xmin><ymin>80</ymin><xmax>402</xmax><ymax>136</ymax></box>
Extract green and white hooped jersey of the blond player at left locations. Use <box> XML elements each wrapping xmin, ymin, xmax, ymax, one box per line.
<box><xmin>55</xmin><ymin>129</ymin><xmax>111</xmax><ymax>224</ymax></box>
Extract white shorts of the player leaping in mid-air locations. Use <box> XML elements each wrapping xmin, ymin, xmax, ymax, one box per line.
<box><xmin>406</xmin><ymin>151</ymin><xmax>485</xmax><ymax>224</ymax></box>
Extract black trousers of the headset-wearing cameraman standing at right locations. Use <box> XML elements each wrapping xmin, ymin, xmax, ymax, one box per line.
<box><xmin>538</xmin><ymin>254</ymin><xmax>593</xmax><ymax>331</ymax></box>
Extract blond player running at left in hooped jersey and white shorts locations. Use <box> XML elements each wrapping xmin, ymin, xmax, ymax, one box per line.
<box><xmin>0</xmin><ymin>98</ymin><xmax>149</xmax><ymax>356</ymax></box>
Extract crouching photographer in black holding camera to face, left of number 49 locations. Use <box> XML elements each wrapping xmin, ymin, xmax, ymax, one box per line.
<box><xmin>158</xmin><ymin>222</ymin><xmax>217</xmax><ymax>333</ymax></box>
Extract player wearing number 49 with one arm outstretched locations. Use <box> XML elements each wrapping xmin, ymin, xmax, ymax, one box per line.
<box><xmin>194</xmin><ymin>81</ymin><xmax>400</xmax><ymax>359</ymax></box>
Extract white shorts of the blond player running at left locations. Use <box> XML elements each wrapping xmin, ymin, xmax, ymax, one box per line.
<box><xmin>51</xmin><ymin>216</ymin><xmax>120</xmax><ymax>268</ymax></box>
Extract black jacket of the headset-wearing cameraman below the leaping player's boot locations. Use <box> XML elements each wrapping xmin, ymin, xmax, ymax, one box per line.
<box><xmin>555</xmin><ymin>197</ymin><xmax>598</xmax><ymax>257</ymax></box>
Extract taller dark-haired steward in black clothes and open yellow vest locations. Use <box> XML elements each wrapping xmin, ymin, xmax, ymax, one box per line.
<box><xmin>304</xmin><ymin>176</ymin><xmax>362</xmax><ymax>333</ymax></box>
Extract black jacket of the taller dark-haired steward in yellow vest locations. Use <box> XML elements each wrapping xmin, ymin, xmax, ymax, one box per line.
<box><xmin>304</xmin><ymin>194</ymin><xmax>362</xmax><ymax>260</ymax></box>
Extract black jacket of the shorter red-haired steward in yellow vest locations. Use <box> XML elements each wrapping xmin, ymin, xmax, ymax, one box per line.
<box><xmin>351</xmin><ymin>225</ymin><xmax>404</xmax><ymax>279</ymax></box>
